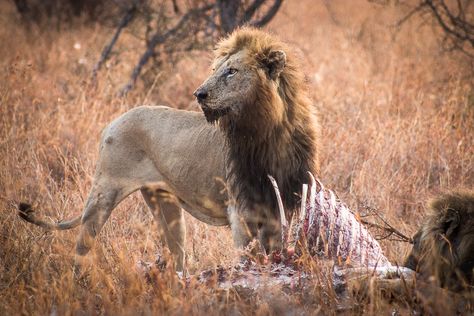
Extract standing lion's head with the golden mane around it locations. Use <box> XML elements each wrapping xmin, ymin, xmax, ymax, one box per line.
<box><xmin>194</xmin><ymin>27</ymin><xmax>308</xmax><ymax>134</ymax></box>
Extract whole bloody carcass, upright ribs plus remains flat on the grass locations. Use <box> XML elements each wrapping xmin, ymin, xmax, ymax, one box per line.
<box><xmin>140</xmin><ymin>175</ymin><xmax>400</xmax><ymax>295</ymax></box>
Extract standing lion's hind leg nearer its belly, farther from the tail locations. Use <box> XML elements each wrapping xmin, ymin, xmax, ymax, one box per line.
<box><xmin>141</xmin><ymin>185</ymin><xmax>186</xmax><ymax>271</ymax></box>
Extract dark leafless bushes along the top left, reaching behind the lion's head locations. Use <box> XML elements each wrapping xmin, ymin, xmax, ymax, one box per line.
<box><xmin>13</xmin><ymin>0</ymin><xmax>283</xmax><ymax>95</ymax></box>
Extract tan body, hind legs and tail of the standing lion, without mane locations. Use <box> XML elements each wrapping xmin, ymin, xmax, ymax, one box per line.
<box><xmin>20</xmin><ymin>106</ymin><xmax>228</xmax><ymax>270</ymax></box>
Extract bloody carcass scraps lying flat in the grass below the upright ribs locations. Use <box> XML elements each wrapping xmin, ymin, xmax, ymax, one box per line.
<box><xmin>137</xmin><ymin>258</ymin><xmax>415</xmax><ymax>300</ymax></box>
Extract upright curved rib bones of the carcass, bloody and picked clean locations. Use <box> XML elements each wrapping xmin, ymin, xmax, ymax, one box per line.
<box><xmin>268</xmin><ymin>175</ymin><xmax>391</xmax><ymax>267</ymax></box>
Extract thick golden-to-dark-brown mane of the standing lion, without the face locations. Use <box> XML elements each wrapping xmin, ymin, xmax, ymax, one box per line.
<box><xmin>210</xmin><ymin>27</ymin><xmax>319</xmax><ymax>216</ymax></box>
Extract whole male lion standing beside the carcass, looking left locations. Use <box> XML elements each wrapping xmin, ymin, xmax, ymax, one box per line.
<box><xmin>20</xmin><ymin>28</ymin><xmax>318</xmax><ymax>270</ymax></box>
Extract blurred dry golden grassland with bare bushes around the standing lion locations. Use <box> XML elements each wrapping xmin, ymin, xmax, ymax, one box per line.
<box><xmin>0</xmin><ymin>0</ymin><xmax>474</xmax><ymax>314</ymax></box>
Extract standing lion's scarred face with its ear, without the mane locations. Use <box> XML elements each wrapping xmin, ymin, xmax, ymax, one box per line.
<box><xmin>194</xmin><ymin>49</ymin><xmax>285</xmax><ymax>123</ymax></box>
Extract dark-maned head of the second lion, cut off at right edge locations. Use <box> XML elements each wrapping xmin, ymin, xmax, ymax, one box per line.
<box><xmin>405</xmin><ymin>191</ymin><xmax>474</xmax><ymax>291</ymax></box>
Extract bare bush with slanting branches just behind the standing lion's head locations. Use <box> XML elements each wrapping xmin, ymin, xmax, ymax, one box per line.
<box><xmin>93</xmin><ymin>0</ymin><xmax>282</xmax><ymax>95</ymax></box>
